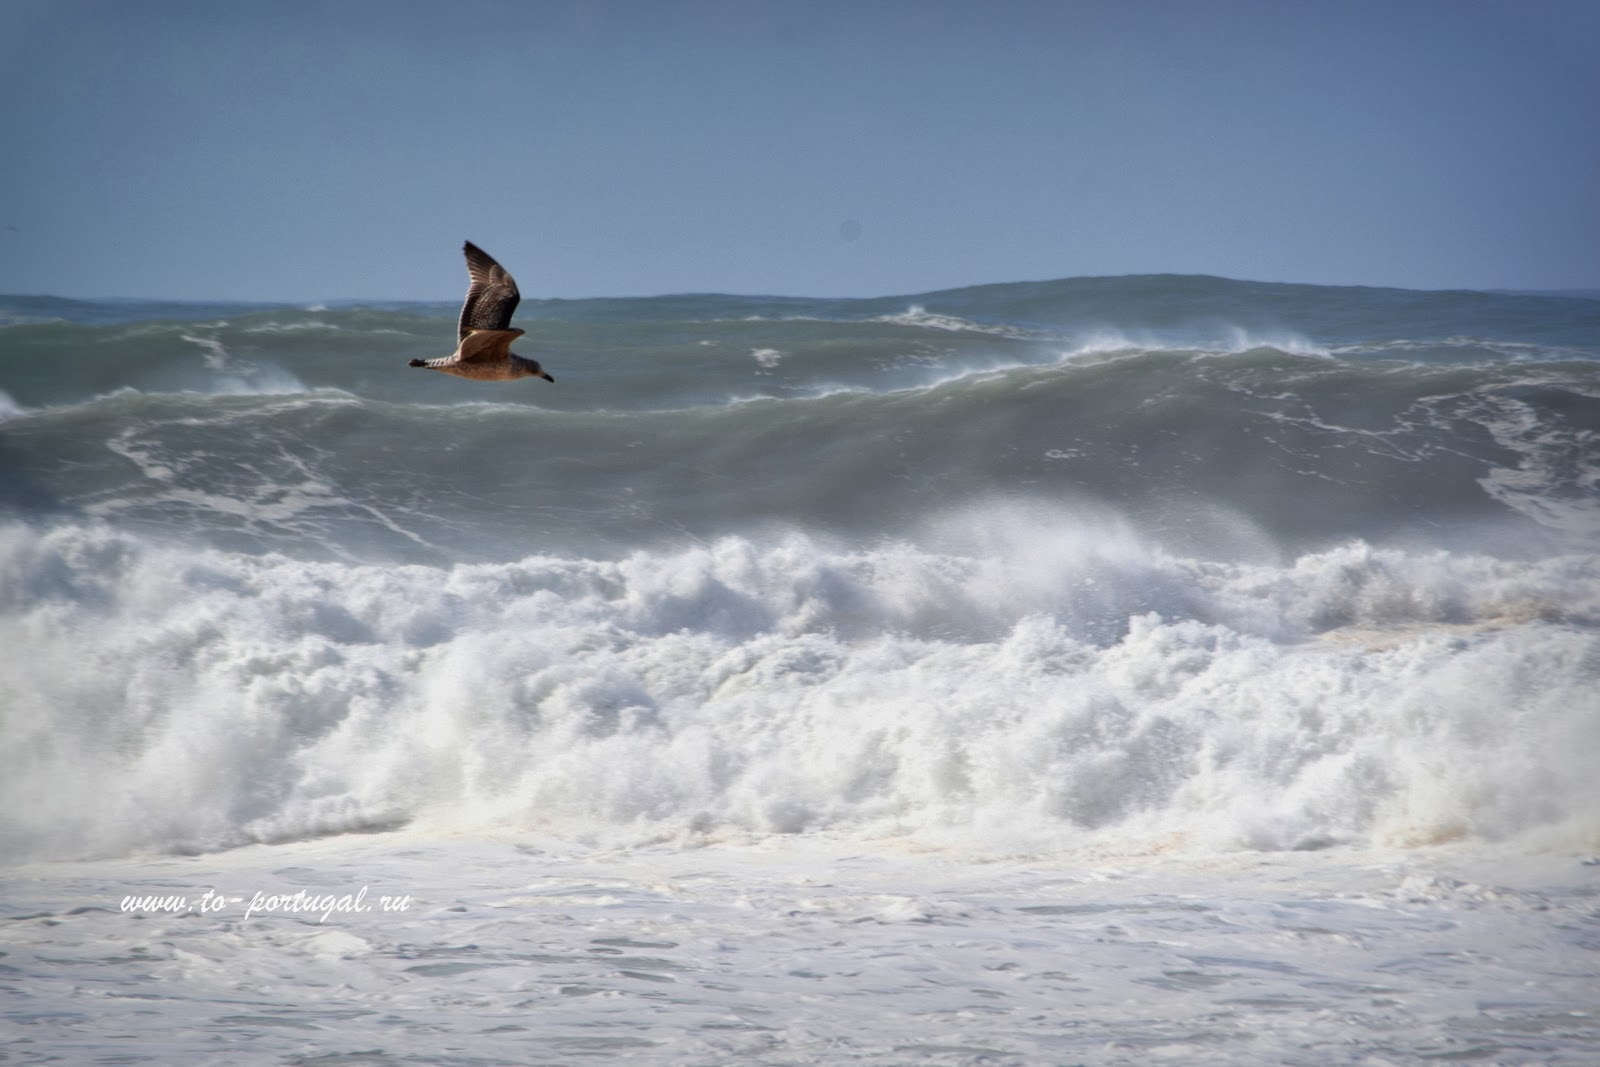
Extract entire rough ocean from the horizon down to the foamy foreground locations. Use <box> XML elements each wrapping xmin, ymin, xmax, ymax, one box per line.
<box><xmin>0</xmin><ymin>275</ymin><xmax>1600</xmax><ymax>1067</ymax></box>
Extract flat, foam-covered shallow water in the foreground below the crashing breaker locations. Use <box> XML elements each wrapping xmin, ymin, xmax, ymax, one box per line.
<box><xmin>5</xmin><ymin>833</ymin><xmax>1600</xmax><ymax>1067</ymax></box>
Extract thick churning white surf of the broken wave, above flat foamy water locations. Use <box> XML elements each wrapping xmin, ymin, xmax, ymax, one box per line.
<box><xmin>0</xmin><ymin>517</ymin><xmax>1600</xmax><ymax>854</ymax></box>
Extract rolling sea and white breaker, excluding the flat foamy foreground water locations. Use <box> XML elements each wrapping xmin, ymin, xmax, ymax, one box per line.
<box><xmin>0</xmin><ymin>277</ymin><xmax>1600</xmax><ymax>856</ymax></box>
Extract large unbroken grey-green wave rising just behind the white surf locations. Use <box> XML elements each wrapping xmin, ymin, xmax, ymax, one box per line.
<box><xmin>0</xmin><ymin>349</ymin><xmax>1600</xmax><ymax>563</ymax></box>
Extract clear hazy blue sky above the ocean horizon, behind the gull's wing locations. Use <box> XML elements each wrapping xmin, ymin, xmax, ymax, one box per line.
<box><xmin>0</xmin><ymin>0</ymin><xmax>1600</xmax><ymax>301</ymax></box>
